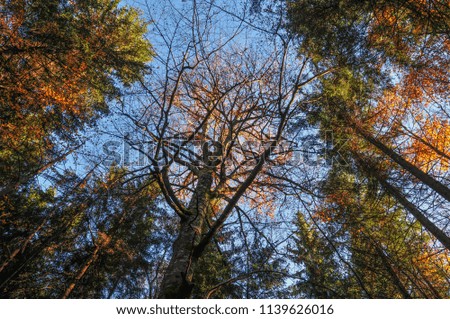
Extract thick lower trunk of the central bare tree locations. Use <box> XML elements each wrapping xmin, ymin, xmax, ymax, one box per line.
<box><xmin>158</xmin><ymin>169</ymin><xmax>212</xmax><ymax>299</ymax></box>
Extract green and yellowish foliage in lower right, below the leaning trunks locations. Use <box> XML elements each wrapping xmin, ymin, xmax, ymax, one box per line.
<box><xmin>292</xmin><ymin>162</ymin><xmax>449</xmax><ymax>298</ymax></box>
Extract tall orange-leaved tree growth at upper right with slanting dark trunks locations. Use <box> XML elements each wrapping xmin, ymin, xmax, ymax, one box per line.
<box><xmin>290</xmin><ymin>1</ymin><xmax>450</xmax><ymax>254</ymax></box>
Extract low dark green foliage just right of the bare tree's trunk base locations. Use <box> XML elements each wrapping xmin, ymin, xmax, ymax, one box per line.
<box><xmin>193</xmin><ymin>231</ymin><xmax>286</xmax><ymax>299</ymax></box>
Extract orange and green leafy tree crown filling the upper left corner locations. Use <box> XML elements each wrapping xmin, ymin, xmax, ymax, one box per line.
<box><xmin>0</xmin><ymin>0</ymin><xmax>152</xmax><ymax>197</ymax></box>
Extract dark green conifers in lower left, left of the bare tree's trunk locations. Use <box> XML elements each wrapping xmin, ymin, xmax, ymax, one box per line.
<box><xmin>0</xmin><ymin>168</ymin><xmax>163</xmax><ymax>298</ymax></box>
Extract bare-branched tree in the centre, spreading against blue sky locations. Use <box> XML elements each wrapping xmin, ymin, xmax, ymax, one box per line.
<box><xmin>114</xmin><ymin>1</ymin><xmax>327</xmax><ymax>298</ymax></box>
